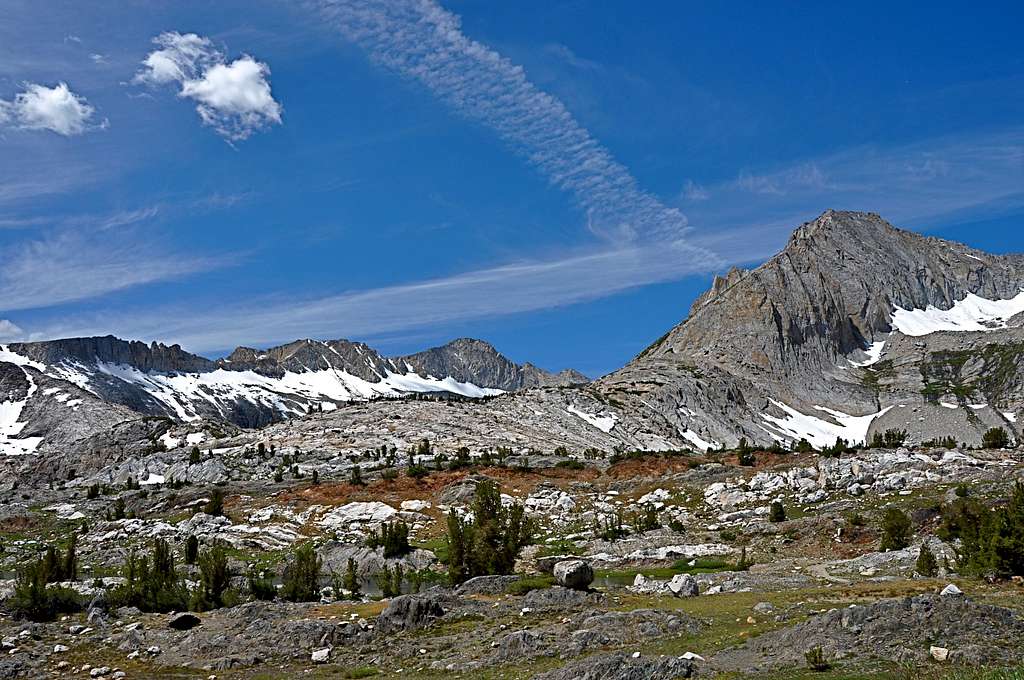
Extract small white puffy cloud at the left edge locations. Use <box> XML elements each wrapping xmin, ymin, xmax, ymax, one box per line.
<box><xmin>0</xmin><ymin>83</ymin><xmax>96</xmax><ymax>137</ymax></box>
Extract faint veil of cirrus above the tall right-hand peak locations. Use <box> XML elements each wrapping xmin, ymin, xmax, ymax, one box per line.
<box><xmin>687</xmin><ymin>128</ymin><xmax>1024</xmax><ymax>238</ymax></box>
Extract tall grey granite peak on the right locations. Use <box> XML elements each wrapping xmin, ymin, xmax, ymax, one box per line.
<box><xmin>596</xmin><ymin>211</ymin><xmax>1024</xmax><ymax>444</ymax></box>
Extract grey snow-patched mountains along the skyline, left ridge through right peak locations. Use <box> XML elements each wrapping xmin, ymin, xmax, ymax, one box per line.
<box><xmin>0</xmin><ymin>211</ymin><xmax>1024</xmax><ymax>466</ymax></box>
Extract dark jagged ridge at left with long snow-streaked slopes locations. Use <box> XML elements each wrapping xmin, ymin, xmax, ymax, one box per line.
<box><xmin>0</xmin><ymin>337</ymin><xmax>537</xmax><ymax>431</ymax></box>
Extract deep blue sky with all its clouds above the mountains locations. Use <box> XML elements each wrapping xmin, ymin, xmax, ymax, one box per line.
<box><xmin>0</xmin><ymin>0</ymin><xmax>1024</xmax><ymax>376</ymax></box>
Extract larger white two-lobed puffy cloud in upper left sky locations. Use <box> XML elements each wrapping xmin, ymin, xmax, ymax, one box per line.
<box><xmin>134</xmin><ymin>32</ymin><xmax>281</xmax><ymax>141</ymax></box>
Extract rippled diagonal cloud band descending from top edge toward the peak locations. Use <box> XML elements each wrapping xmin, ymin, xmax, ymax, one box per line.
<box><xmin>308</xmin><ymin>0</ymin><xmax>715</xmax><ymax>251</ymax></box>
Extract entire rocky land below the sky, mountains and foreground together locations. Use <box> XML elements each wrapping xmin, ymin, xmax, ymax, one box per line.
<box><xmin>0</xmin><ymin>211</ymin><xmax>1024</xmax><ymax>680</ymax></box>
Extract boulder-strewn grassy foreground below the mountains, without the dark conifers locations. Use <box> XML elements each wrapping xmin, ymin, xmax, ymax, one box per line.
<box><xmin>0</xmin><ymin>438</ymin><xmax>1024</xmax><ymax>678</ymax></box>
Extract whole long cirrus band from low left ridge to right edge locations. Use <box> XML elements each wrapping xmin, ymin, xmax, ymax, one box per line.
<box><xmin>23</xmin><ymin>125</ymin><xmax>1024</xmax><ymax>351</ymax></box>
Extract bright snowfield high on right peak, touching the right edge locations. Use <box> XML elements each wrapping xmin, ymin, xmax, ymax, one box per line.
<box><xmin>892</xmin><ymin>291</ymin><xmax>1024</xmax><ymax>337</ymax></box>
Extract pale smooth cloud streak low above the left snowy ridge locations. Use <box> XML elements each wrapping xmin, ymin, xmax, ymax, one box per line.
<box><xmin>24</xmin><ymin>238</ymin><xmax>707</xmax><ymax>352</ymax></box>
